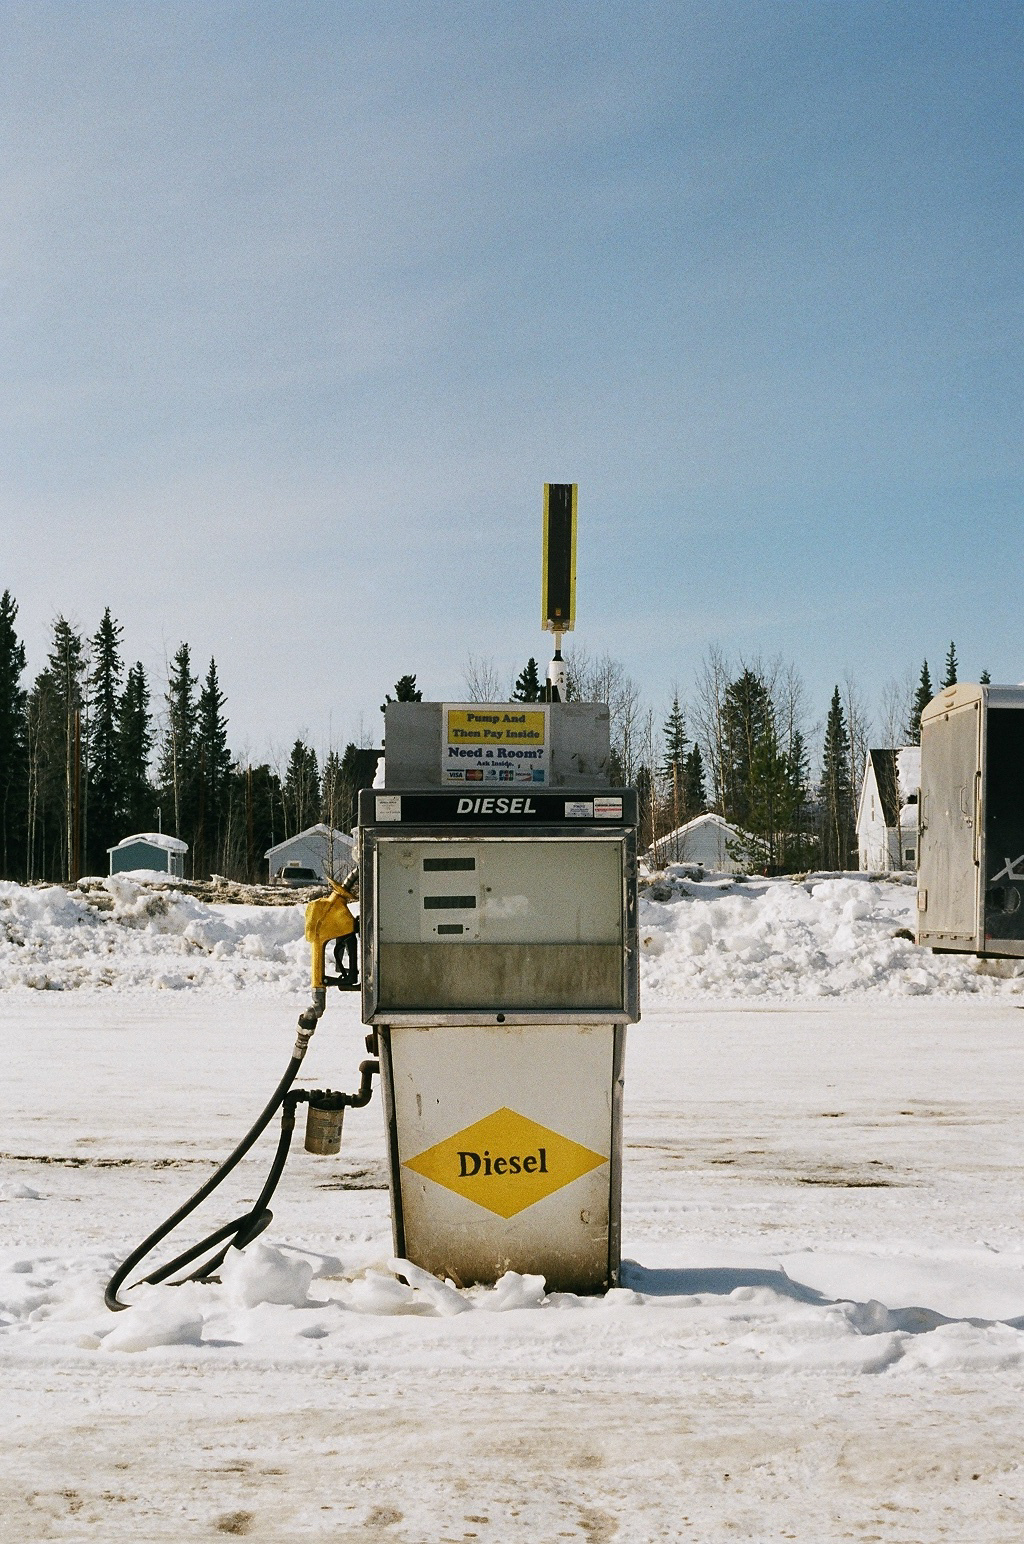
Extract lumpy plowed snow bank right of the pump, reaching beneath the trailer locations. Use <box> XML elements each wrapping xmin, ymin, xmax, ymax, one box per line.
<box><xmin>639</xmin><ymin>875</ymin><xmax>1024</xmax><ymax>999</ymax></box>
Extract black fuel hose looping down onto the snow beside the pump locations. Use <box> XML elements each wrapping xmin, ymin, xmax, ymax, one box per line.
<box><xmin>103</xmin><ymin>1056</ymin><xmax>303</xmax><ymax>1312</ymax></box>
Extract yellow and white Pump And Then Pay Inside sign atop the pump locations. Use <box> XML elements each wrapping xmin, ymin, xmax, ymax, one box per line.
<box><xmin>440</xmin><ymin>703</ymin><xmax>551</xmax><ymax>787</ymax></box>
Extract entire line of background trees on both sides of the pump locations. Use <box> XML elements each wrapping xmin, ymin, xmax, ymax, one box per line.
<box><xmin>0</xmin><ymin>591</ymin><xmax>988</xmax><ymax>882</ymax></box>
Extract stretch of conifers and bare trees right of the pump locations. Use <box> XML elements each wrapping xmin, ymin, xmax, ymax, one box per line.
<box><xmin>465</xmin><ymin>642</ymin><xmax>990</xmax><ymax>874</ymax></box>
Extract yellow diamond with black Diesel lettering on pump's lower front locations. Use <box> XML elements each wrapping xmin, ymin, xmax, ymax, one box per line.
<box><xmin>405</xmin><ymin>1109</ymin><xmax>609</xmax><ymax>1217</ymax></box>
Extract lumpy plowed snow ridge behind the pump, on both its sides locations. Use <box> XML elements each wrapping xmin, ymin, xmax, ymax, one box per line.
<box><xmin>0</xmin><ymin>871</ymin><xmax>1024</xmax><ymax>999</ymax></box>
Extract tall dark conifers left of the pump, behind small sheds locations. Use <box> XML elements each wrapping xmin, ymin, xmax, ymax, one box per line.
<box><xmin>0</xmin><ymin>591</ymin><xmax>379</xmax><ymax>883</ymax></box>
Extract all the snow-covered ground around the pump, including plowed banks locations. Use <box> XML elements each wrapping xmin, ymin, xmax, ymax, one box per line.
<box><xmin>0</xmin><ymin>879</ymin><xmax>1024</xmax><ymax>1544</ymax></box>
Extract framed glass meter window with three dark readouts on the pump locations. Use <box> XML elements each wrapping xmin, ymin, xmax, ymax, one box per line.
<box><xmin>377</xmin><ymin>835</ymin><xmax>624</xmax><ymax>1011</ymax></box>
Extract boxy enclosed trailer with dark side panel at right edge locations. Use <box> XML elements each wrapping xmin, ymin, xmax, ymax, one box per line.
<box><xmin>917</xmin><ymin>682</ymin><xmax>1024</xmax><ymax>956</ymax></box>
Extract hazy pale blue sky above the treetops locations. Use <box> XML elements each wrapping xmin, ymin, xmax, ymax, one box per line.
<box><xmin>0</xmin><ymin>0</ymin><xmax>1024</xmax><ymax>755</ymax></box>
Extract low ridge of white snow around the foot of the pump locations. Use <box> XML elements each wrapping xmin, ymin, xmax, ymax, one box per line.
<box><xmin>0</xmin><ymin>1243</ymin><xmax>1024</xmax><ymax>1377</ymax></box>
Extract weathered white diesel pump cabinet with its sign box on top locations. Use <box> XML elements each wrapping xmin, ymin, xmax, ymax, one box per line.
<box><xmin>360</xmin><ymin>701</ymin><xmax>639</xmax><ymax>1292</ymax></box>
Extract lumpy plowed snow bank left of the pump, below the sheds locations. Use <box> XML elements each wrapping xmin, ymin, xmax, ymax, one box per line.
<box><xmin>0</xmin><ymin>874</ymin><xmax>309</xmax><ymax>991</ymax></box>
